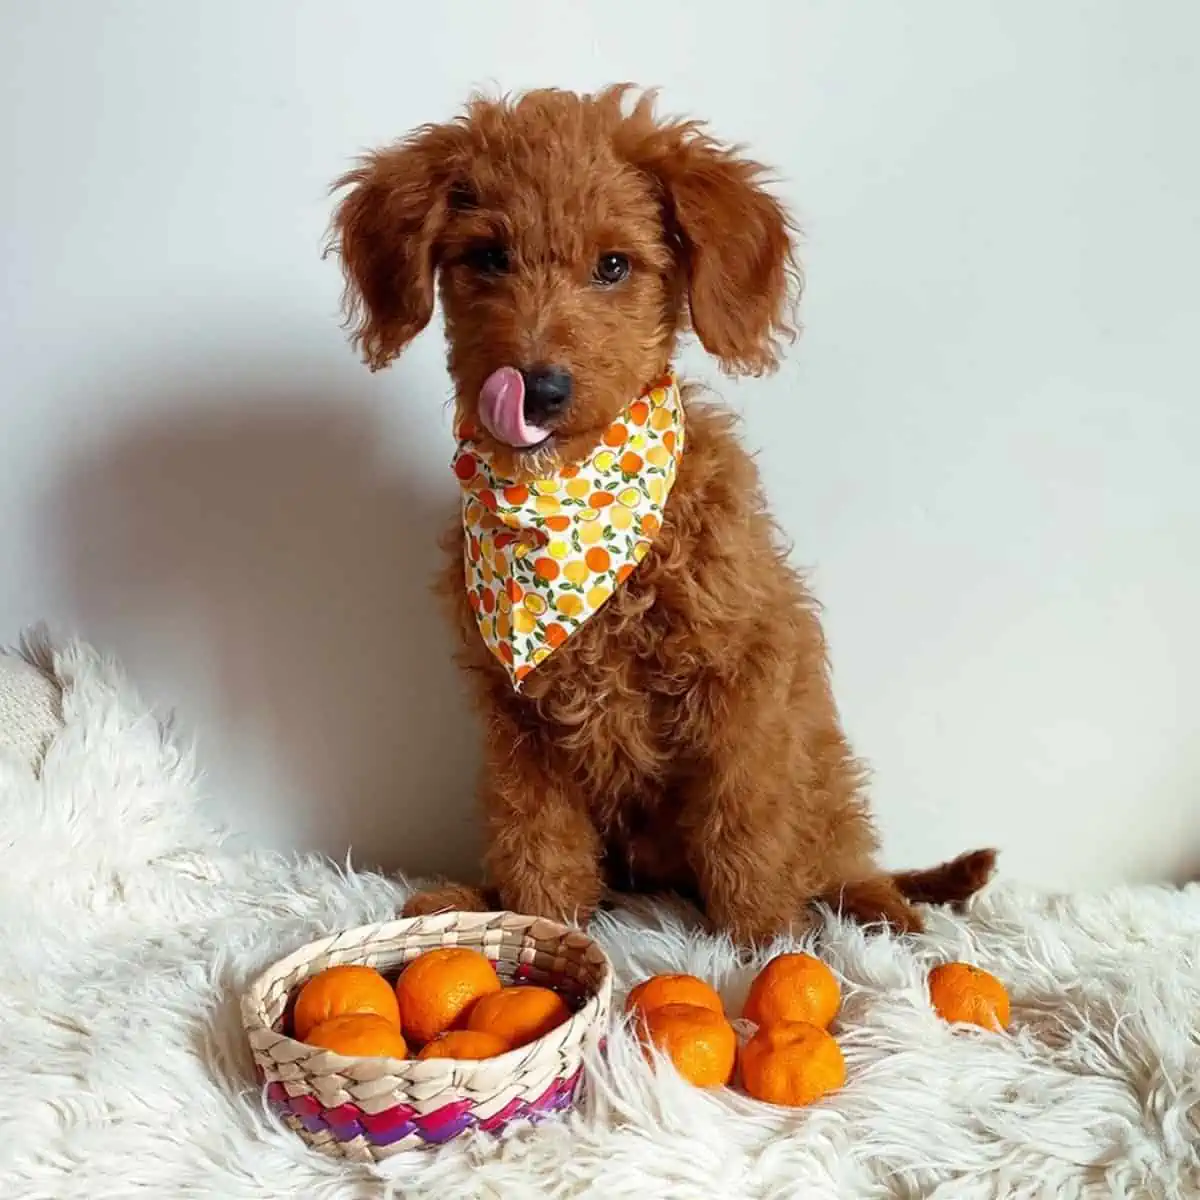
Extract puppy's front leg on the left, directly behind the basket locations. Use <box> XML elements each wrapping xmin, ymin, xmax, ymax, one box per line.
<box><xmin>484</xmin><ymin>757</ymin><xmax>602</xmax><ymax>925</ymax></box>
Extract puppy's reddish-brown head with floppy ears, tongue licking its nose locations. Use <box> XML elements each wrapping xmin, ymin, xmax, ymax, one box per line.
<box><xmin>334</xmin><ymin>88</ymin><xmax>799</xmax><ymax>461</ymax></box>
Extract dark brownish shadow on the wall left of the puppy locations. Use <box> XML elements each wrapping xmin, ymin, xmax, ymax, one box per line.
<box><xmin>52</xmin><ymin>361</ymin><xmax>479</xmax><ymax>878</ymax></box>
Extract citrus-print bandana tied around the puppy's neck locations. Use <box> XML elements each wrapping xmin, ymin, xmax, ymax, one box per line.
<box><xmin>454</xmin><ymin>376</ymin><xmax>684</xmax><ymax>691</ymax></box>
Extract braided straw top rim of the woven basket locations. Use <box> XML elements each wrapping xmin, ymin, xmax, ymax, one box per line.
<box><xmin>240</xmin><ymin>908</ymin><xmax>614</xmax><ymax>1082</ymax></box>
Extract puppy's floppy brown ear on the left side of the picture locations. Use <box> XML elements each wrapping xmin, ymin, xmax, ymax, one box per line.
<box><xmin>329</xmin><ymin>125</ymin><xmax>461</xmax><ymax>371</ymax></box>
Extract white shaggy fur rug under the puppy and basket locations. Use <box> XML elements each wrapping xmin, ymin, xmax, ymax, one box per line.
<box><xmin>0</xmin><ymin>633</ymin><xmax>1200</xmax><ymax>1200</ymax></box>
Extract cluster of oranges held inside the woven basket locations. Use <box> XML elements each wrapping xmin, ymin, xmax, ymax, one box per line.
<box><xmin>292</xmin><ymin>947</ymin><xmax>570</xmax><ymax>1058</ymax></box>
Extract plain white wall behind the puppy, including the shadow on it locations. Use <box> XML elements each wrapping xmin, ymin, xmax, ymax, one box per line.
<box><xmin>0</xmin><ymin>0</ymin><xmax>1200</xmax><ymax>883</ymax></box>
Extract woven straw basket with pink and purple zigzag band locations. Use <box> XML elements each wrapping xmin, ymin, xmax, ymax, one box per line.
<box><xmin>241</xmin><ymin>912</ymin><xmax>612</xmax><ymax>1162</ymax></box>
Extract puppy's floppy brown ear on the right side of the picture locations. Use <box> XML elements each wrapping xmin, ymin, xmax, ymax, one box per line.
<box><xmin>626</xmin><ymin>96</ymin><xmax>802</xmax><ymax>374</ymax></box>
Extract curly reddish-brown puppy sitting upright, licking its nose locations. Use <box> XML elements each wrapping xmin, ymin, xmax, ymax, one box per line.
<box><xmin>335</xmin><ymin>88</ymin><xmax>994</xmax><ymax>942</ymax></box>
